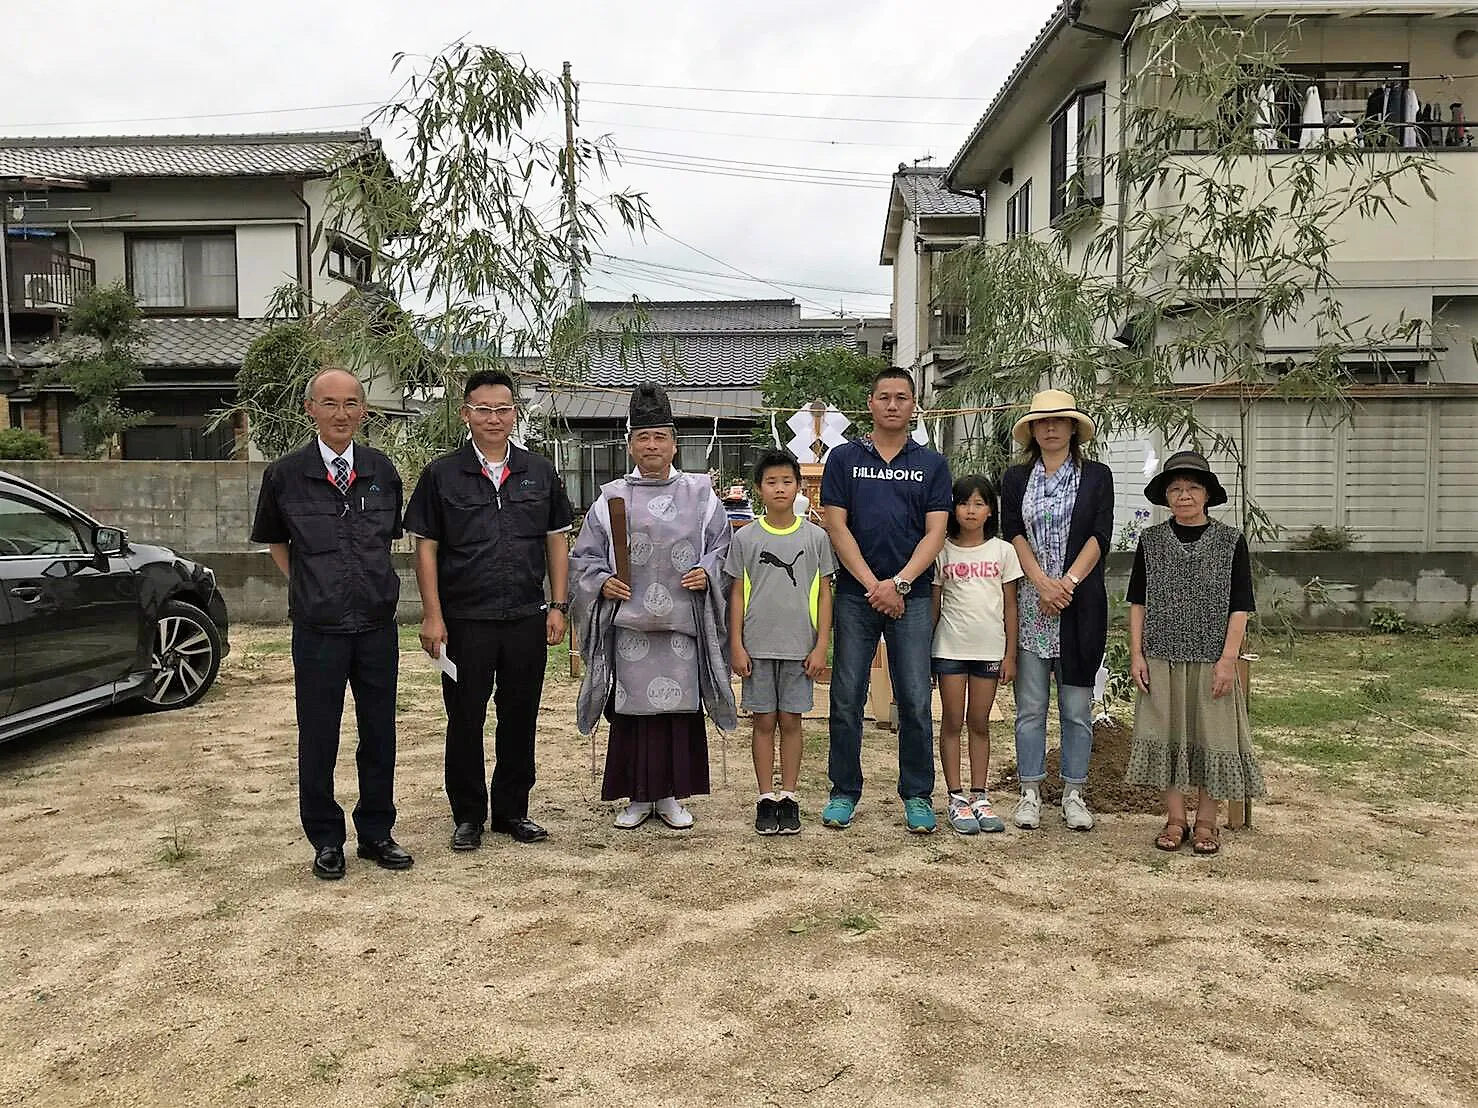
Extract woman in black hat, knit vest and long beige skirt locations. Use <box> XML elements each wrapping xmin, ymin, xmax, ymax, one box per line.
<box><xmin>1125</xmin><ymin>451</ymin><xmax>1264</xmax><ymax>854</ymax></box>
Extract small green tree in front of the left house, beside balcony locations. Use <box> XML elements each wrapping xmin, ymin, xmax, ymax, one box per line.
<box><xmin>38</xmin><ymin>288</ymin><xmax>149</xmax><ymax>456</ymax></box>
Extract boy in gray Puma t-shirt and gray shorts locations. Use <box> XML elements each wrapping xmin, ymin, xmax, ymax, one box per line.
<box><xmin>724</xmin><ymin>451</ymin><xmax>837</xmax><ymax>835</ymax></box>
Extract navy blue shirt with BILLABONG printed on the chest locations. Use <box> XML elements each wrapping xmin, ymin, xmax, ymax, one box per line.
<box><xmin>822</xmin><ymin>439</ymin><xmax>955</xmax><ymax>595</ymax></box>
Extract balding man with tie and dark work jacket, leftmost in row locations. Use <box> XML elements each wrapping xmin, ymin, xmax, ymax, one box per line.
<box><xmin>251</xmin><ymin>369</ymin><xmax>411</xmax><ymax>880</ymax></box>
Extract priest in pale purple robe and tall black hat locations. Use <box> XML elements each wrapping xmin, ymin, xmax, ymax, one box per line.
<box><xmin>571</xmin><ymin>383</ymin><xmax>736</xmax><ymax>830</ymax></box>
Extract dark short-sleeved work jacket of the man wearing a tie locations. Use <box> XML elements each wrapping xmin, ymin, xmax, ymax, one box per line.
<box><xmin>251</xmin><ymin>436</ymin><xmax>402</xmax><ymax>634</ymax></box>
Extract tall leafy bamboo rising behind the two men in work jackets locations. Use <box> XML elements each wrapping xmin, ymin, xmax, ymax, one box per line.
<box><xmin>218</xmin><ymin>43</ymin><xmax>652</xmax><ymax>473</ymax></box>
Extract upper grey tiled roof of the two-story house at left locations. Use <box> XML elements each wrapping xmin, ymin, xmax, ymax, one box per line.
<box><xmin>0</xmin><ymin>131</ymin><xmax>380</xmax><ymax>179</ymax></box>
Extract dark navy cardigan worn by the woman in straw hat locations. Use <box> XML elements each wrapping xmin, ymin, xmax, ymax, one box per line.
<box><xmin>1001</xmin><ymin>458</ymin><xmax>1113</xmax><ymax>687</ymax></box>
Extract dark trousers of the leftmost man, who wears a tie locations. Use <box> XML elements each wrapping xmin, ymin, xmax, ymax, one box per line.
<box><xmin>293</xmin><ymin>623</ymin><xmax>401</xmax><ymax>849</ymax></box>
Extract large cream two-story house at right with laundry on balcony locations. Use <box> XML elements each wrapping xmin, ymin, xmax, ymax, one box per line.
<box><xmin>943</xmin><ymin>0</ymin><xmax>1478</xmax><ymax>550</ymax></box>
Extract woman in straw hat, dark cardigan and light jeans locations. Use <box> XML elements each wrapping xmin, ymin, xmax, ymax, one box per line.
<box><xmin>1001</xmin><ymin>389</ymin><xmax>1113</xmax><ymax>830</ymax></box>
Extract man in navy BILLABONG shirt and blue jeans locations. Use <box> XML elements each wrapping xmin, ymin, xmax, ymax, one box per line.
<box><xmin>822</xmin><ymin>369</ymin><xmax>953</xmax><ymax>835</ymax></box>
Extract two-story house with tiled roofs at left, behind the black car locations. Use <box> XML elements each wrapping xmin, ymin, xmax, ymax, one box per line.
<box><xmin>0</xmin><ymin>131</ymin><xmax>405</xmax><ymax>459</ymax></box>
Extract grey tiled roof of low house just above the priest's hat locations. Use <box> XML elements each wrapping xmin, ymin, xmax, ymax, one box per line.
<box><xmin>584</xmin><ymin>328</ymin><xmax>850</xmax><ymax>389</ymax></box>
